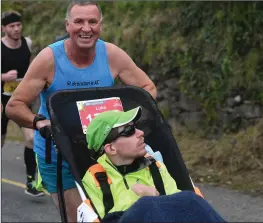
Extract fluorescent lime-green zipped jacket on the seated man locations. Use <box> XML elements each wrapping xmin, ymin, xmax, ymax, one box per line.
<box><xmin>82</xmin><ymin>154</ymin><xmax>180</xmax><ymax>218</ymax></box>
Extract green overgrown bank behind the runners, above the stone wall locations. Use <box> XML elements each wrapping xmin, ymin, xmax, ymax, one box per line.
<box><xmin>2</xmin><ymin>1</ymin><xmax>263</xmax><ymax>125</ymax></box>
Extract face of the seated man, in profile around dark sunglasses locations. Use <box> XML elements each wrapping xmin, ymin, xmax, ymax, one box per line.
<box><xmin>112</xmin><ymin>123</ymin><xmax>146</xmax><ymax>159</ymax></box>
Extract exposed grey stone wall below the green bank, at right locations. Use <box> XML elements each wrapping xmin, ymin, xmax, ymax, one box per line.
<box><xmin>155</xmin><ymin>78</ymin><xmax>263</xmax><ymax>133</ymax></box>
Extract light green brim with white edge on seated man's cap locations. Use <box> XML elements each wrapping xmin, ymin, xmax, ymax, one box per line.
<box><xmin>113</xmin><ymin>107</ymin><xmax>142</xmax><ymax>128</ymax></box>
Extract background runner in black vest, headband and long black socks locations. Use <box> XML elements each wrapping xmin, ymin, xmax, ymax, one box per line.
<box><xmin>1</xmin><ymin>11</ymin><xmax>44</xmax><ymax>196</ymax></box>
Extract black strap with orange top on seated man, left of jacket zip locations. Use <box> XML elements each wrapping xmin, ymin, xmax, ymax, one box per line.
<box><xmin>89</xmin><ymin>164</ymin><xmax>114</xmax><ymax>215</ymax></box>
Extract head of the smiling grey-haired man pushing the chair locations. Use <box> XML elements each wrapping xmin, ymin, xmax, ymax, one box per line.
<box><xmin>66</xmin><ymin>5</ymin><xmax>102</xmax><ymax>49</ymax></box>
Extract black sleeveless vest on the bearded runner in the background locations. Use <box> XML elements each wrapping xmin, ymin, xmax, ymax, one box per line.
<box><xmin>1</xmin><ymin>37</ymin><xmax>31</xmax><ymax>101</ymax></box>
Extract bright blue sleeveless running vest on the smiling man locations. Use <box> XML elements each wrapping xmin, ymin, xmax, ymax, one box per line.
<box><xmin>34</xmin><ymin>40</ymin><xmax>114</xmax><ymax>162</ymax></box>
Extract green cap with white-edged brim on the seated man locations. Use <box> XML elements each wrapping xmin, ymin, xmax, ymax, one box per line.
<box><xmin>86</xmin><ymin>107</ymin><xmax>141</xmax><ymax>152</ymax></box>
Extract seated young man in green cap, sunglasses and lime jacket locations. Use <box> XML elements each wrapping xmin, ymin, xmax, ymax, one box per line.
<box><xmin>82</xmin><ymin>107</ymin><xmax>180</xmax><ymax>218</ymax></box>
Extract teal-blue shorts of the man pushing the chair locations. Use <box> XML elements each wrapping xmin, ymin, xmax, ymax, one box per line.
<box><xmin>36</xmin><ymin>155</ymin><xmax>76</xmax><ymax>193</ymax></box>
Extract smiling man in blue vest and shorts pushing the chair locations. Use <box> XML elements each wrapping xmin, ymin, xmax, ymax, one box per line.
<box><xmin>6</xmin><ymin>1</ymin><xmax>157</xmax><ymax>222</ymax></box>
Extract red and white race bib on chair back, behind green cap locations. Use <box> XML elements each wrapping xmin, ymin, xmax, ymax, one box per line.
<box><xmin>77</xmin><ymin>97</ymin><xmax>123</xmax><ymax>134</ymax></box>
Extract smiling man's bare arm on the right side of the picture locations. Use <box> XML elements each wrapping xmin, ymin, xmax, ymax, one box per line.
<box><xmin>106</xmin><ymin>43</ymin><xmax>157</xmax><ymax>99</ymax></box>
